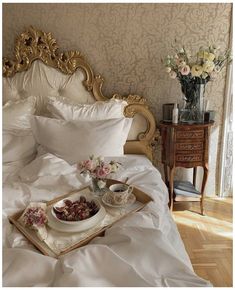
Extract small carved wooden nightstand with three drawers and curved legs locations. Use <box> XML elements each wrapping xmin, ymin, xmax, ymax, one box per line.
<box><xmin>160</xmin><ymin>122</ymin><xmax>214</xmax><ymax>215</ymax></box>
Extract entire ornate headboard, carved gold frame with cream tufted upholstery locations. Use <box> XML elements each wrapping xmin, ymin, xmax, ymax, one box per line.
<box><xmin>3</xmin><ymin>27</ymin><xmax>155</xmax><ymax>159</ymax></box>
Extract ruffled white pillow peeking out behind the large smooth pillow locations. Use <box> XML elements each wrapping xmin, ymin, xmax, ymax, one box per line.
<box><xmin>47</xmin><ymin>97</ymin><xmax>128</xmax><ymax>121</ymax></box>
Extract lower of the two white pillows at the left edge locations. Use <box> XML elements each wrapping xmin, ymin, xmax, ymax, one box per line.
<box><xmin>2</xmin><ymin>130</ymin><xmax>36</xmax><ymax>164</ymax></box>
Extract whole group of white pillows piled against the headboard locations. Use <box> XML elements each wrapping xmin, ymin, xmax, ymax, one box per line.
<box><xmin>3</xmin><ymin>97</ymin><xmax>132</xmax><ymax>165</ymax></box>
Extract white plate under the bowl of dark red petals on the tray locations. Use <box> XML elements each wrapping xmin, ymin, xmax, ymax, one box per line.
<box><xmin>47</xmin><ymin>194</ymin><xmax>106</xmax><ymax>233</ymax></box>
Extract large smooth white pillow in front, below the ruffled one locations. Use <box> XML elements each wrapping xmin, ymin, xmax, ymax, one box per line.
<box><xmin>31</xmin><ymin>116</ymin><xmax>132</xmax><ymax>164</ymax></box>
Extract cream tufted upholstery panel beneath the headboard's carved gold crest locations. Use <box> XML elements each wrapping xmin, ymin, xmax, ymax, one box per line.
<box><xmin>3</xmin><ymin>60</ymin><xmax>95</xmax><ymax>104</ymax></box>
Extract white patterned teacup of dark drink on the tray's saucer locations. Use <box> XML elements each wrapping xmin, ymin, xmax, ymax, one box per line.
<box><xmin>109</xmin><ymin>183</ymin><xmax>133</xmax><ymax>205</ymax></box>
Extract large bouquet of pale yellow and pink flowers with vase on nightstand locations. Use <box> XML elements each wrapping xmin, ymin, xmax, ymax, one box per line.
<box><xmin>162</xmin><ymin>45</ymin><xmax>232</xmax><ymax>122</ymax></box>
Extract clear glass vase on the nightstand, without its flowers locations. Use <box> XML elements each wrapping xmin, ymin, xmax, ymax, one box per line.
<box><xmin>180</xmin><ymin>82</ymin><xmax>206</xmax><ymax>124</ymax></box>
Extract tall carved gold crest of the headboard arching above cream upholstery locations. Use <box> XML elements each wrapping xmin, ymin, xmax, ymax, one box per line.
<box><xmin>3</xmin><ymin>26</ymin><xmax>105</xmax><ymax>100</ymax></box>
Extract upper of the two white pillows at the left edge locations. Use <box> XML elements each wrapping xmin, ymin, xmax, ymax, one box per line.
<box><xmin>2</xmin><ymin>97</ymin><xmax>36</xmax><ymax>130</ymax></box>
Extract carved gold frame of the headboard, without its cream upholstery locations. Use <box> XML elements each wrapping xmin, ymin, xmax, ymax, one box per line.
<box><xmin>3</xmin><ymin>27</ymin><xmax>156</xmax><ymax>160</ymax></box>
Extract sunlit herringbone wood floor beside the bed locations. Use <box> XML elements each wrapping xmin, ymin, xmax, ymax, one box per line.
<box><xmin>173</xmin><ymin>198</ymin><xmax>233</xmax><ymax>287</ymax></box>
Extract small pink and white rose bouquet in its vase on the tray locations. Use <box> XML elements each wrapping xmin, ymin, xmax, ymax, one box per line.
<box><xmin>78</xmin><ymin>155</ymin><xmax>121</xmax><ymax>195</ymax></box>
